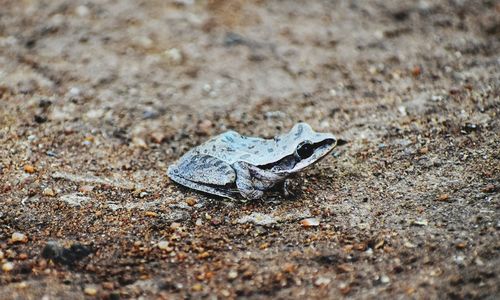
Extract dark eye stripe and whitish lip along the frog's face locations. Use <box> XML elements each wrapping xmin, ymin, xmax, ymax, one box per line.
<box><xmin>260</xmin><ymin>138</ymin><xmax>337</xmax><ymax>173</ymax></box>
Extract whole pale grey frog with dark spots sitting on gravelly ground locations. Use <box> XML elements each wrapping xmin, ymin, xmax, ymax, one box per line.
<box><xmin>167</xmin><ymin>123</ymin><xmax>337</xmax><ymax>200</ymax></box>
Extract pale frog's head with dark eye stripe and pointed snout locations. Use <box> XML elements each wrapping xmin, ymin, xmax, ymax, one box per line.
<box><xmin>269</xmin><ymin>123</ymin><xmax>337</xmax><ymax>174</ymax></box>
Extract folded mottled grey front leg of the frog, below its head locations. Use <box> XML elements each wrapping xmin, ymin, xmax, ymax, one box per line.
<box><xmin>232</xmin><ymin>162</ymin><xmax>284</xmax><ymax>200</ymax></box>
